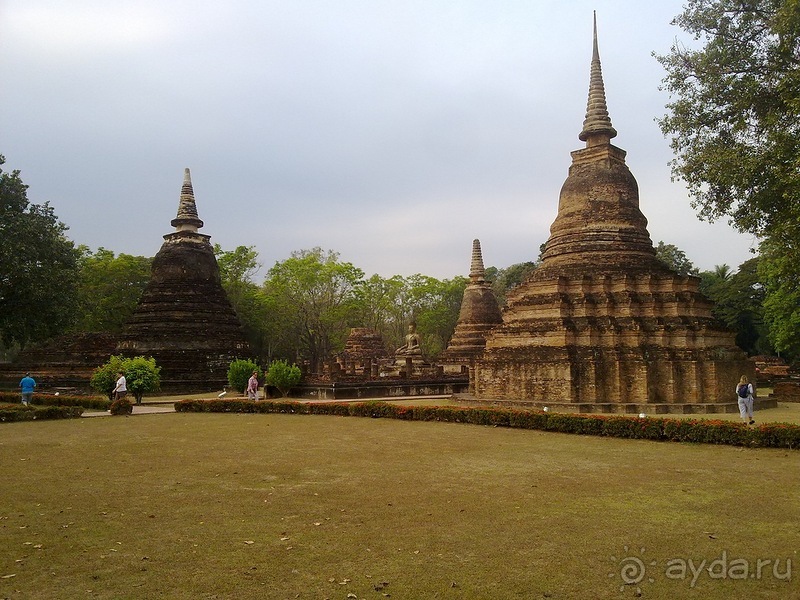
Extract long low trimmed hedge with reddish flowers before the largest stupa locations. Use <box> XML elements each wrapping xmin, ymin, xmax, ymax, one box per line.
<box><xmin>175</xmin><ymin>400</ymin><xmax>800</xmax><ymax>449</ymax></box>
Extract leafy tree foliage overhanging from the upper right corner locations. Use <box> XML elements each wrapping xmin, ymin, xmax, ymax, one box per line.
<box><xmin>656</xmin><ymin>0</ymin><xmax>800</xmax><ymax>237</ymax></box>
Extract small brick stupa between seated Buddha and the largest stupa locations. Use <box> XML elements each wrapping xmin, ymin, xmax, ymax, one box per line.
<box><xmin>437</xmin><ymin>240</ymin><xmax>503</xmax><ymax>373</ymax></box>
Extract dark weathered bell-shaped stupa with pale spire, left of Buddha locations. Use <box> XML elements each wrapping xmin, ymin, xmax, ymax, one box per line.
<box><xmin>117</xmin><ymin>169</ymin><xmax>250</xmax><ymax>392</ymax></box>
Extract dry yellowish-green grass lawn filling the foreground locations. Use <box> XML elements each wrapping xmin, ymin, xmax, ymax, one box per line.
<box><xmin>0</xmin><ymin>411</ymin><xmax>800</xmax><ymax>600</ymax></box>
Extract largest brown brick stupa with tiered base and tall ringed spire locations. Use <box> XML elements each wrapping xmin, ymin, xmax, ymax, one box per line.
<box><xmin>473</xmin><ymin>18</ymin><xmax>754</xmax><ymax>413</ymax></box>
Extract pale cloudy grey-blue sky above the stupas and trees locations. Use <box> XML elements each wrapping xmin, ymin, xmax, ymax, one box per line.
<box><xmin>0</xmin><ymin>0</ymin><xmax>757</xmax><ymax>279</ymax></box>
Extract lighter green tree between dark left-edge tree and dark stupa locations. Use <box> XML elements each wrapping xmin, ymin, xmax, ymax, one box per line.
<box><xmin>74</xmin><ymin>246</ymin><xmax>153</xmax><ymax>333</ymax></box>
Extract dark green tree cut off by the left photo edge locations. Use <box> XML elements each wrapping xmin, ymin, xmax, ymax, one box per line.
<box><xmin>0</xmin><ymin>156</ymin><xmax>78</xmax><ymax>348</ymax></box>
